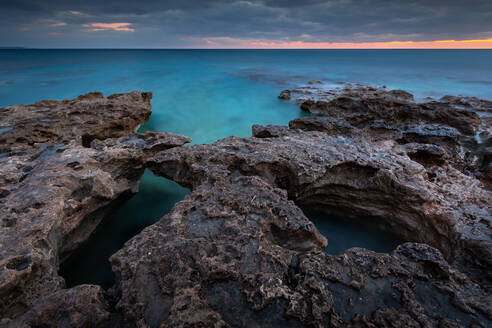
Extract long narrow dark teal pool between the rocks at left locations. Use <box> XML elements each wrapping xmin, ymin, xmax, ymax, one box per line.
<box><xmin>59</xmin><ymin>170</ymin><xmax>189</xmax><ymax>288</ymax></box>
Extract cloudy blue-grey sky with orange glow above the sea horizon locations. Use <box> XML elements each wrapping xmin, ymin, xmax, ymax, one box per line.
<box><xmin>0</xmin><ymin>0</ymin><xmax>492</xmax><ymax>49</ymax></box>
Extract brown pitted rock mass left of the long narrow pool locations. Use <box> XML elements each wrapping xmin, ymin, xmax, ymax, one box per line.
<box><xmin>0</xmin><ymin>92</ymin><xmax>190</xmax><ymax>318</ymax></box>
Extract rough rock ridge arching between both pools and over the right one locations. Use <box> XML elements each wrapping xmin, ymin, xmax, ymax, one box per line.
<box><xmin>148</xmin><ymin>127</ymin><xmax>492</xmax><ymax>277</ymax></box>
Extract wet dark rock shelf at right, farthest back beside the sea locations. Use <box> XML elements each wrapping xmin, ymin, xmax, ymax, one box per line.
<box><xmin>279</xmin><ymin>83</ymin><xmax>492</xmax><ymax>189</ymax></box>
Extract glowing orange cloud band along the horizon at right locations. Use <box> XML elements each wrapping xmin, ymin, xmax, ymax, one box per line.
<box><xmin>199</xmin><ymin>37</ymin><xmax>492</xmax><ymax>49</ymax></box>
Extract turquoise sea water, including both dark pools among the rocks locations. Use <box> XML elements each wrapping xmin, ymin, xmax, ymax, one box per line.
<box><xmin>0</xmin><ymin>50</ymin><xmax>492</xmax><ymax>287</ymax></box>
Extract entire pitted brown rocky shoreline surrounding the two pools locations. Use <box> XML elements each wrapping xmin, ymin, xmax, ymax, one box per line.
<box><xmin>0</xmin><ymin>86</ymin><xmax>492</xmax><ymax>327</ymax></box>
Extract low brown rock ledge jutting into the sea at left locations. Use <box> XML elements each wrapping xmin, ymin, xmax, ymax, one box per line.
<box><xmin>0</xmin><ymin>92</ymin><xmax>152</xmax><ymax>155</ymax></box>
